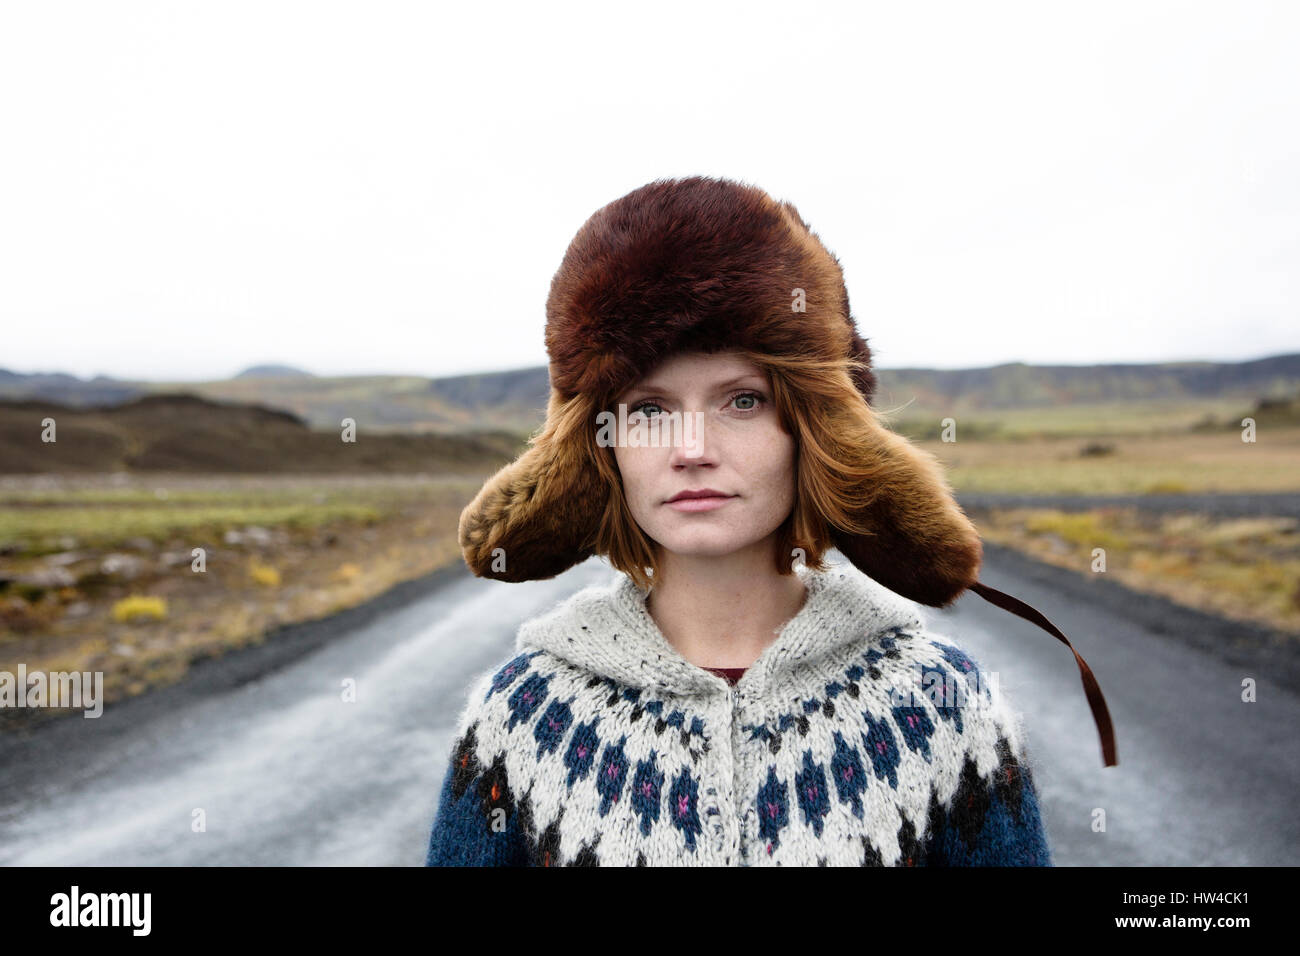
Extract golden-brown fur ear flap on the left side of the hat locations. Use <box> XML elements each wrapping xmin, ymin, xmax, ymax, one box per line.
<box><xmin>456</xmin><ymin>389</ymin><xmax>608</xmax><ymax>581</ymax></box>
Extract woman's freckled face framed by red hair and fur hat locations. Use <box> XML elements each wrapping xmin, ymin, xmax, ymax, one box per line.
<box><xmin>614</xmin><ymin>352</ymin><xmax>794</xmax><ymax>557</ymax></box>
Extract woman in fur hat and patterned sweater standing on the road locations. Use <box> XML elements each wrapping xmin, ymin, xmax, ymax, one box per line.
<box><xmin>426</xmin><ymin>177</ymin><xmax>1114</xmax><ymax>866</ymax></box>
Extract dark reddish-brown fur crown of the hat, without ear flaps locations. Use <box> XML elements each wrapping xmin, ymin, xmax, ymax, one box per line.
<box><xmin>546</xmin><ymin>176</ymin><xmax>876</xmax><ymax>402</ymax></box>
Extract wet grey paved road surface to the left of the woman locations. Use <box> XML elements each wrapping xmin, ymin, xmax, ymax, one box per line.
<box><xmin>0</xmin><ymin>564</ymin><xmax>610</xmax><ymax>866</ymax></box>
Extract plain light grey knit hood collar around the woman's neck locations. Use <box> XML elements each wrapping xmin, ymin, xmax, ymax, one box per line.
<box><xmin>516</xmin><ymin>563</ymin><xmax>923</xmax><ymax>698</ymax></box>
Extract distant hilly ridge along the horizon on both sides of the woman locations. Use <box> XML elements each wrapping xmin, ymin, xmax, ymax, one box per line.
<box><xmin>0</xmin><ymin>352</ymin><xmax>1300</xmax><ymax>440</ymax></box>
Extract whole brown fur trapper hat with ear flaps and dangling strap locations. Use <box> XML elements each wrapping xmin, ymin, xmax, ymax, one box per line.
<box><xmin>459</xmin><ymin>176</ymin><xmax>1118</xmax><ymax>766</ymax></box>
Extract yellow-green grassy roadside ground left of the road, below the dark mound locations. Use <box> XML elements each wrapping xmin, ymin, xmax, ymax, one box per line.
<box><xmin>0</xmin><ymin>475</ymin><xmax>486</xmax><ymax>717</ymax></box>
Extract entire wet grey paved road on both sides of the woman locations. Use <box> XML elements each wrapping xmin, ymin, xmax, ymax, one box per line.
<box><xmin>0</xmin><ymin>549</ymin><xmax>1300</xmax><ymax>865</ymax></box>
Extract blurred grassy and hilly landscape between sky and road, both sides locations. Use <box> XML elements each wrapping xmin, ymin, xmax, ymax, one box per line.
<box><xmin>0</xmin><ymin>354</ymin><xmax>1300</xmax><ymax>721</ymax></box>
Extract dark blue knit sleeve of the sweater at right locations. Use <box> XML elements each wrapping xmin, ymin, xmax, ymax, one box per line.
<box><xmin>926</xmin><ymin>740</ymin><xmax>1053</xmax><ymax>866</ymax></box>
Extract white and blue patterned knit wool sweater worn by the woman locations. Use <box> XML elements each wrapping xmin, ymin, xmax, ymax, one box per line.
<box><xmin>425</xmin><ymin>564</ymin><xmax>1052</xmax><ymax>866</ymax></box>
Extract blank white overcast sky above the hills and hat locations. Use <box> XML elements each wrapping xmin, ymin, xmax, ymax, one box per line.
<box><xmin>0</xmin><ymin>0</ymin><xmax>1300</xmax><ymax>380</ymax></box>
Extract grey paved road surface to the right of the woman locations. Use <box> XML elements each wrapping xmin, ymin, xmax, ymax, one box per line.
<box><xmin>932</xmin><ymin>545</ymin><xmax>1300</xmax><ymax>866</ymax></box>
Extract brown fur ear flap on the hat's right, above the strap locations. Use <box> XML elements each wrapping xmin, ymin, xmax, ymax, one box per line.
<box><xmin>832</xmin><ymin>399</ymin><xmax>984</xmax><ymax>607</ymax></box>
